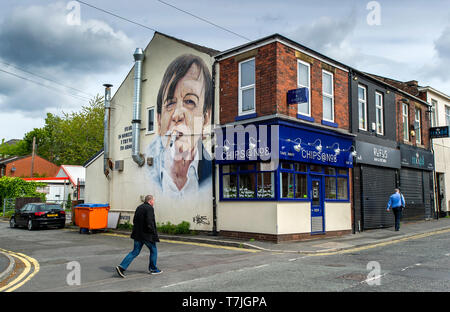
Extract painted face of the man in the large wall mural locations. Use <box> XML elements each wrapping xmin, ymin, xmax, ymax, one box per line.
<box><xmin>158</xmin><ymin>64</ymin><xmax>209</xmax><ymax>160</ymax></box>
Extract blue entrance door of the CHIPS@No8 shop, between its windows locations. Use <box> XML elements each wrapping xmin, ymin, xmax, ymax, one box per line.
<box><xmin>311</xmin><ymin>177</ymin><xmax>325</xmax><ymax>234</ymax></box>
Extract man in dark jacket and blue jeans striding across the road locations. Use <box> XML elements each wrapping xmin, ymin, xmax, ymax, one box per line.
<box><xmin>116</xmin><ymin>195</ymin><xmax>162</xmax><ymax>277</ymax></box>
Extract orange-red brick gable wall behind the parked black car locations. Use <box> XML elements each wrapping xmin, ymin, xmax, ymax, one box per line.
<box><xmin>5</xmin><ymin>156</ymin><xmax>59</xmax><ymax>178</ymax></box>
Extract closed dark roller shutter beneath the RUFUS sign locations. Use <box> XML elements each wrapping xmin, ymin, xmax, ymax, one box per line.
<box><xmin>361</xmin><ymin>166</ymin><xmax>395</xmax><ymax>230</ymax></box>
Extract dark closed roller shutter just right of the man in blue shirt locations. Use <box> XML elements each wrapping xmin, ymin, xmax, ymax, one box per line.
<box><xmin>400</xmin><ymin>168</ymin><xmax>431</xmax><ymax>221</ymax></box>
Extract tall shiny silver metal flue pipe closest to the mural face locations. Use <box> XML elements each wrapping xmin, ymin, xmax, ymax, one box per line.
<box><xmin>131</xmin><ymin>48</ymin><xmax>145</xmax><ymax>167</ymax></box>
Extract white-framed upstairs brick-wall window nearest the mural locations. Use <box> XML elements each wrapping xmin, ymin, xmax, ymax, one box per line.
<box><xmin>239</xmin><ymin>58</ymin><xmax>255</xmax><ymax>115</ymax></box>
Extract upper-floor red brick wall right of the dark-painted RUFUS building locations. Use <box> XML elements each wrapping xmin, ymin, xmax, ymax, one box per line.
<box><xmin>395</xmin><ymin>93</ymin><xmax>430</xmax><ymax>149</ymax></box>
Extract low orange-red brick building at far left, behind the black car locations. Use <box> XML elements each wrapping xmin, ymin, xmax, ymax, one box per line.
<box><xmin>0</xmin><ymin>155</ymin><xmax>59</xmax><ymax>178</ymax></box>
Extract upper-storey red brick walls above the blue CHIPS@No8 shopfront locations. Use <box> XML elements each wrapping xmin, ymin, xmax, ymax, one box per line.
<box><xmin>220</xmin><ymin>42</ymin><xmax>350</xmax><ymax>130</ymax></box>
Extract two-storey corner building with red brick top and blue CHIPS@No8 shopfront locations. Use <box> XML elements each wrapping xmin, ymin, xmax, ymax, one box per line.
<box><xmin>215</xmin><ymin>34</ymin><xmax>354</xmax><ymax>242</ymax></box>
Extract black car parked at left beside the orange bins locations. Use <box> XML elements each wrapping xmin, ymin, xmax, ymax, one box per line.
<box><xmin>9</xmin><ymin>203</ymin><xmax>66</xmax><ymax>231</ymax></box>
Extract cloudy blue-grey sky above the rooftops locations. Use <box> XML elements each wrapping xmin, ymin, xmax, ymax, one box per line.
<box><xmin>0</xmin><ymin>0</ymin><xmax>450</xmax><ymax>140</ymax></box>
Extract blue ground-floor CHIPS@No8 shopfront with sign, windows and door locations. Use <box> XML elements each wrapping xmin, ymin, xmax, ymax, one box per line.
<box><xmin>216</xmin><ymin>119</ymin><xmax>354</xmax><ymax>239</ymax></box>
